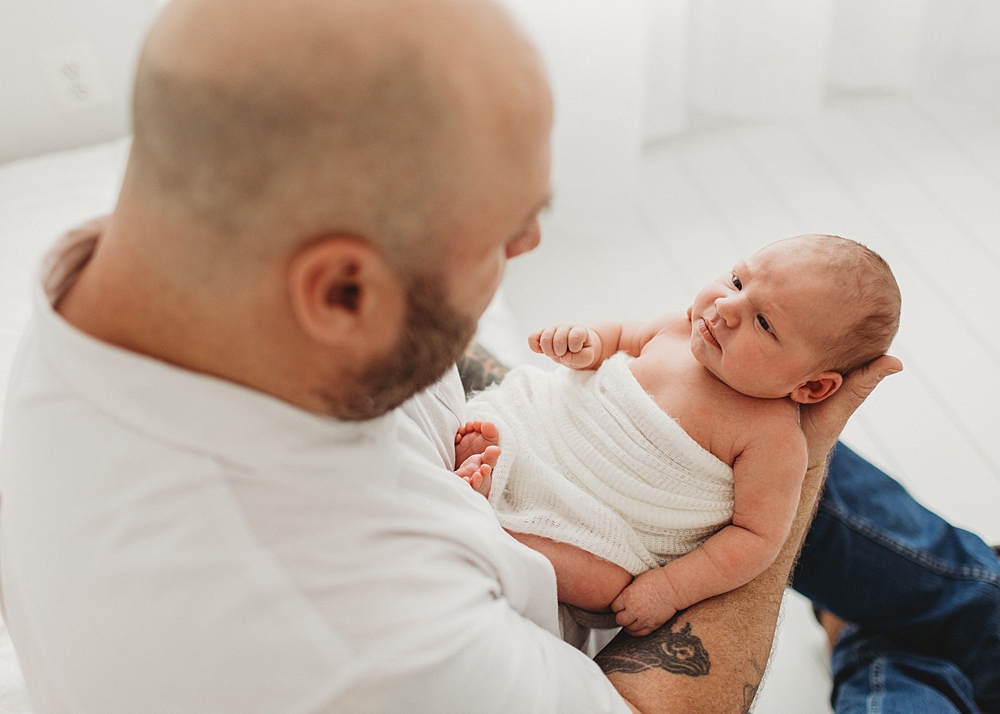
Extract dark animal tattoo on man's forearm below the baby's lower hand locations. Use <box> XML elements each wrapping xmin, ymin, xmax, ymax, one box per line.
<box><xmin>595</xmin><ymin>613</ymin><xmax>712</xmax><ymax>677</ymax></box>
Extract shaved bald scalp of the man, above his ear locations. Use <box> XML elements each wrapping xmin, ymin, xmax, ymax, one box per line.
<box><xmin>126</xmin><ymin>0</ymin><xmax>548</xmax><ymax>274</ymax></box>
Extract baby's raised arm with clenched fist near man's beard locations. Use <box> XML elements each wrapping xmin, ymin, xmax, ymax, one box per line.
<box><xmin>528</xmin><ymin>315</ymin><xmax>671</xmax><ymax>369</ymax></box>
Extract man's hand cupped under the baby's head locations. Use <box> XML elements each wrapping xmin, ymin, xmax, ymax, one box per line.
<box><xmin>799</xmin><ymin>355</ymin><xmax>903</xmax><ymax>469</ymax></box>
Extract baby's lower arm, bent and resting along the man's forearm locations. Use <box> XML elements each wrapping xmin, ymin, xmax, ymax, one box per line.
<box><xmin>611</xmin><ymin>423</ymin><xmax>807</xmax><ymax>635</ymax></box>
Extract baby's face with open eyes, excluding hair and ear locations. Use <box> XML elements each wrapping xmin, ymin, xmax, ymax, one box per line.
<box><xmin>690</xmin><ymin>238</ymin><xmax>850</xmax><ymax>399</ymax></box>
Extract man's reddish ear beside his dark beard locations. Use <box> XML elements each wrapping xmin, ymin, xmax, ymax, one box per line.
<box><xmin>288</xmin><ymin>235</ymin><xmax>403</xmax><ymax>351</ymax></box>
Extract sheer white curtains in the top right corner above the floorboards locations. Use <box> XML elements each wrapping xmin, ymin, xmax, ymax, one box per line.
<box><xmin>645</xmin><ymin>0</ymin><xmax>1000</xmax><ymax>141</ymax></box>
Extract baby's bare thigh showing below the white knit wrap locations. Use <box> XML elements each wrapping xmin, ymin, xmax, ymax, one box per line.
<box><xmin>511</xmin><ymin>533</ymin><xmax>632</xmax><ymax>612</ymax></box>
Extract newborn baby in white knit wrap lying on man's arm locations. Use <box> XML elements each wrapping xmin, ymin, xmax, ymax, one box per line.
<box><xmin>456</xmin><ymin>235</ymin><xmax>900</xmax><ymax>635</ymax></box>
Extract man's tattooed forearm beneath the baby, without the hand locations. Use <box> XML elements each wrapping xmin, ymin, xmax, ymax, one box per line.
<box><xmin>596</xmin><ymin>458</ymin><xmax>826</xmax><ymax>714</ymax></box>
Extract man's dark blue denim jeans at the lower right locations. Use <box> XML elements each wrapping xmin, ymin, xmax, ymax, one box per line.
<box><xmin>794</xmin><ymin>444</ymin><xmax>1000</xmax><ymax>714</ymax></box>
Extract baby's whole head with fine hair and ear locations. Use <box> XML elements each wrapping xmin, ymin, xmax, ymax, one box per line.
<box><xmin>689</xmin><ymin>235</ymin><xmax>901</xmax><ymax>404</ymax></box>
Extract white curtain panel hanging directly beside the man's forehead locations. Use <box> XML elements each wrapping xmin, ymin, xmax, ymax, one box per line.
<box><xmin>504</xmin><ymin>0</ymin><xmax>648</xmax><ymax>230</ymax></box>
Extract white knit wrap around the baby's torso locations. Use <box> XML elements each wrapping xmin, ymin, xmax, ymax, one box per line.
<box><xmin>468</xmin><ymin>353</ymin><xmax>733</xmax><ymax>575</ymax></box>
